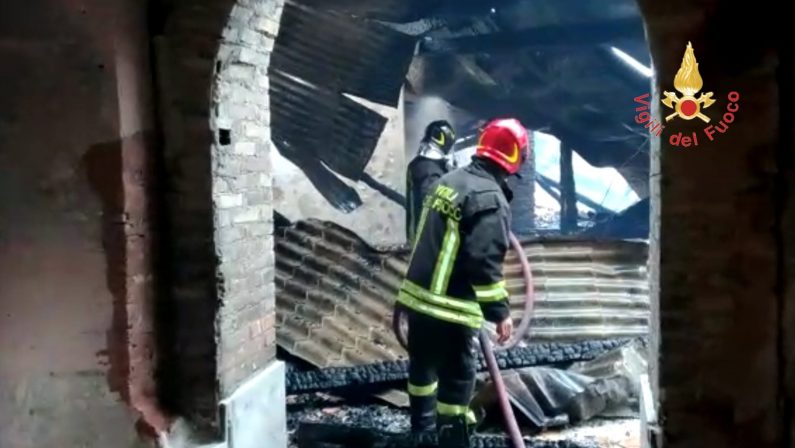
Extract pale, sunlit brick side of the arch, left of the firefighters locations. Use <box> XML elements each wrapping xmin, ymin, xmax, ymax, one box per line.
<box><xmin>212</xmin><ymin>0</ymin><xmax>284</xmax><ymax>395</ymax></box>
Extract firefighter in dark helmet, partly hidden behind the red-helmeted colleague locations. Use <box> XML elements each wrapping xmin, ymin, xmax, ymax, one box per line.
<box><xmin>406</xmin><ymin>120</ymin><xmax>455</xmax><ymax>242</ymax></box>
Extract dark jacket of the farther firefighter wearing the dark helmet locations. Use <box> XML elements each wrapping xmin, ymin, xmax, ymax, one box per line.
<box><xmin>406</xmin><ymin>156</ymin><xmax>447</xmax><ymax>243</ymax></box>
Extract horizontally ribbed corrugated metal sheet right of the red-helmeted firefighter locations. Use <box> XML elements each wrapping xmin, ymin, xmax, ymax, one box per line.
<box><xmin>505</xmin><ymin>240</ymin><xmax>649</xmax><ymax>341</ymax></box>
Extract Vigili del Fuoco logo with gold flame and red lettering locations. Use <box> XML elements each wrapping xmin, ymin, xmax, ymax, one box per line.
<box><xmin>635</xmin><ymin>42</ymin><xmax>740</xmax><ymax>148</ymax></box>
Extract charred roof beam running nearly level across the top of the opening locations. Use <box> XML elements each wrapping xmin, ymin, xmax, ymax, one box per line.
<box><xmin>419</xmin><ymin>17</ymin><xmax>646</xmax><ymax>55</ymax></box>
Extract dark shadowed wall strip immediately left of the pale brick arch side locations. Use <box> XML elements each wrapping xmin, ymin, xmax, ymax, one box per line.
<box><xmin>156</xmin><ymin>0</ymin><xmax>233</xmax><ymax>428</ymax></box>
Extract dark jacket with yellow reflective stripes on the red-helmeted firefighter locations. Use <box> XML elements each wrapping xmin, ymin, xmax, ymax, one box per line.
<box><xmin>398</xmin><ymin>159</ymin><xmax>510</xmax><ymax>328</ymax></box>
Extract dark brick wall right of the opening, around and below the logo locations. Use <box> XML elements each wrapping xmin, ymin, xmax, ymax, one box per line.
<box><xmin>639</xmin><ymin>1</ymin><xmax>791</xmax><ymax>447</ymax></box>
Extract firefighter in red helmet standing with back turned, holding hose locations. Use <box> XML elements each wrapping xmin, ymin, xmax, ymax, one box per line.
<box><xmin>397</xmin><ymin>119</ymin><xmax>530</xmax><ymax>448</ymax></box>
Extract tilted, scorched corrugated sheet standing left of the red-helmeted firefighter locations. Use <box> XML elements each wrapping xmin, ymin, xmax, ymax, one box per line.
<box><xmin>276</xmin><ymin>221</ymin><xmax>405</xmax><ymax>367</ymax></box>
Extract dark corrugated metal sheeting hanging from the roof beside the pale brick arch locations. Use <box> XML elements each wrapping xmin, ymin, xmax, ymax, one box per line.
<box><xmin>269</xmin><ymin>2</ymin><xmax>415</xmax><ymax>181</ymax></box>
